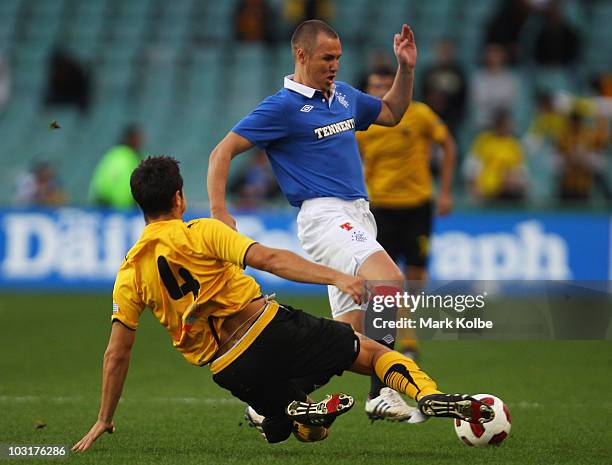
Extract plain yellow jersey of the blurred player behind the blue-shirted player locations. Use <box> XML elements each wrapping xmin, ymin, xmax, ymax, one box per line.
<box><xmin>357</xmin><ymin>102</ymin><xmax>448</xmax><ymax>208</ymax></box>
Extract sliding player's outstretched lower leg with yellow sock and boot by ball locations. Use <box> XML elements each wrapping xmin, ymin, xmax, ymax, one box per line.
<box><xmin>351</xmin><ymin>335</ymin><xmax>495</xmax><ymax>423</ymax></box>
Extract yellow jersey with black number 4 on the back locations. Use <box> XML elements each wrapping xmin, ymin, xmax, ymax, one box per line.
<box><xmin>112</xmin><ymin>219</ymin><xmax>261</xmax><ymax>365</ymax></box>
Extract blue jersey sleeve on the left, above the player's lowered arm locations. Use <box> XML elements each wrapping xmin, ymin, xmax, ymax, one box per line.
<box><xmin>232</xmin><ymin>96</ymin><xmax>288</xmax><ymax>149</ymax></box>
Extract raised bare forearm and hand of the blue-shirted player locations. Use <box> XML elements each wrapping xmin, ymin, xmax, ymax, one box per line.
<box><xmin>376</xmin><ymin>24</ymin><xmax>417</xmax><ymax>126</ymax></box>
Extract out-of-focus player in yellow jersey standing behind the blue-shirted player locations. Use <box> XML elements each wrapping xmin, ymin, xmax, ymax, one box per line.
<box><xmin>357</xmin><ymin>66</ymin><xmax>456</xmax><ymax>356</ymax></box>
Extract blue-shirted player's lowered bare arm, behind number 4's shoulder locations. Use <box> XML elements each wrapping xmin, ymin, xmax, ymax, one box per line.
<box><xmin>206</xmin><ymin>131</ymin><xmax>253</xmax><ymax>229</ymax></box>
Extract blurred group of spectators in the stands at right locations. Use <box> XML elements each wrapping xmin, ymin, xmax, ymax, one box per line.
<box><xmin>370</xmin><ymin>0</ymin><xmax>612</xmax><ymax>204</ymax></box>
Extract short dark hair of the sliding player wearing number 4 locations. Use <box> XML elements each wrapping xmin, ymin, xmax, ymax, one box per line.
<box><xmin>130</xmin><ymin>155</ymin><xmax>183</xmax><ymax>217</ymax></box>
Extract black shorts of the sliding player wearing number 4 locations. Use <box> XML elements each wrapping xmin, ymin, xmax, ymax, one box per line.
<box><xmin>213</xmin><ymin>306</ymin><xmax>359</xmax><ymax>442</ymax></box>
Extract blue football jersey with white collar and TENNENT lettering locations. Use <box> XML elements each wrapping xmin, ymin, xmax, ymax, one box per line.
<box><xmin>232</xmin><ymin>76</ymin><xmax>382</xmax><ymax>207</ymax></box>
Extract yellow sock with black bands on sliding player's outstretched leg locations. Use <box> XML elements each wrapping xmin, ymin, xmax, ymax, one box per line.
<box><xmin>374</xmin><ymin>351</ymin><xmax>440</xmax><ymax>400</ymax></box>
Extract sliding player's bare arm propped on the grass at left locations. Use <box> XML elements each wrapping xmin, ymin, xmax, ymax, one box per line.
<box><xmin>72</xmin><ymin>322</ymin><xmax>136</xmax><ymax>452</ymax></box>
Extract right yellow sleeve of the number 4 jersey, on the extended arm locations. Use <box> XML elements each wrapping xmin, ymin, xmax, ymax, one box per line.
<box><xmin>190</xmin><ymin>219</ymin><xmax>257</xmax><ymax>268</ymax></box>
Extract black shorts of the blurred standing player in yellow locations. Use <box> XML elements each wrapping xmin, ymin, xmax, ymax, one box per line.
<box><xmin>372</xmin><ymin>202</ymin><xmax>433</xmax><ymax>268</ymax></box>
